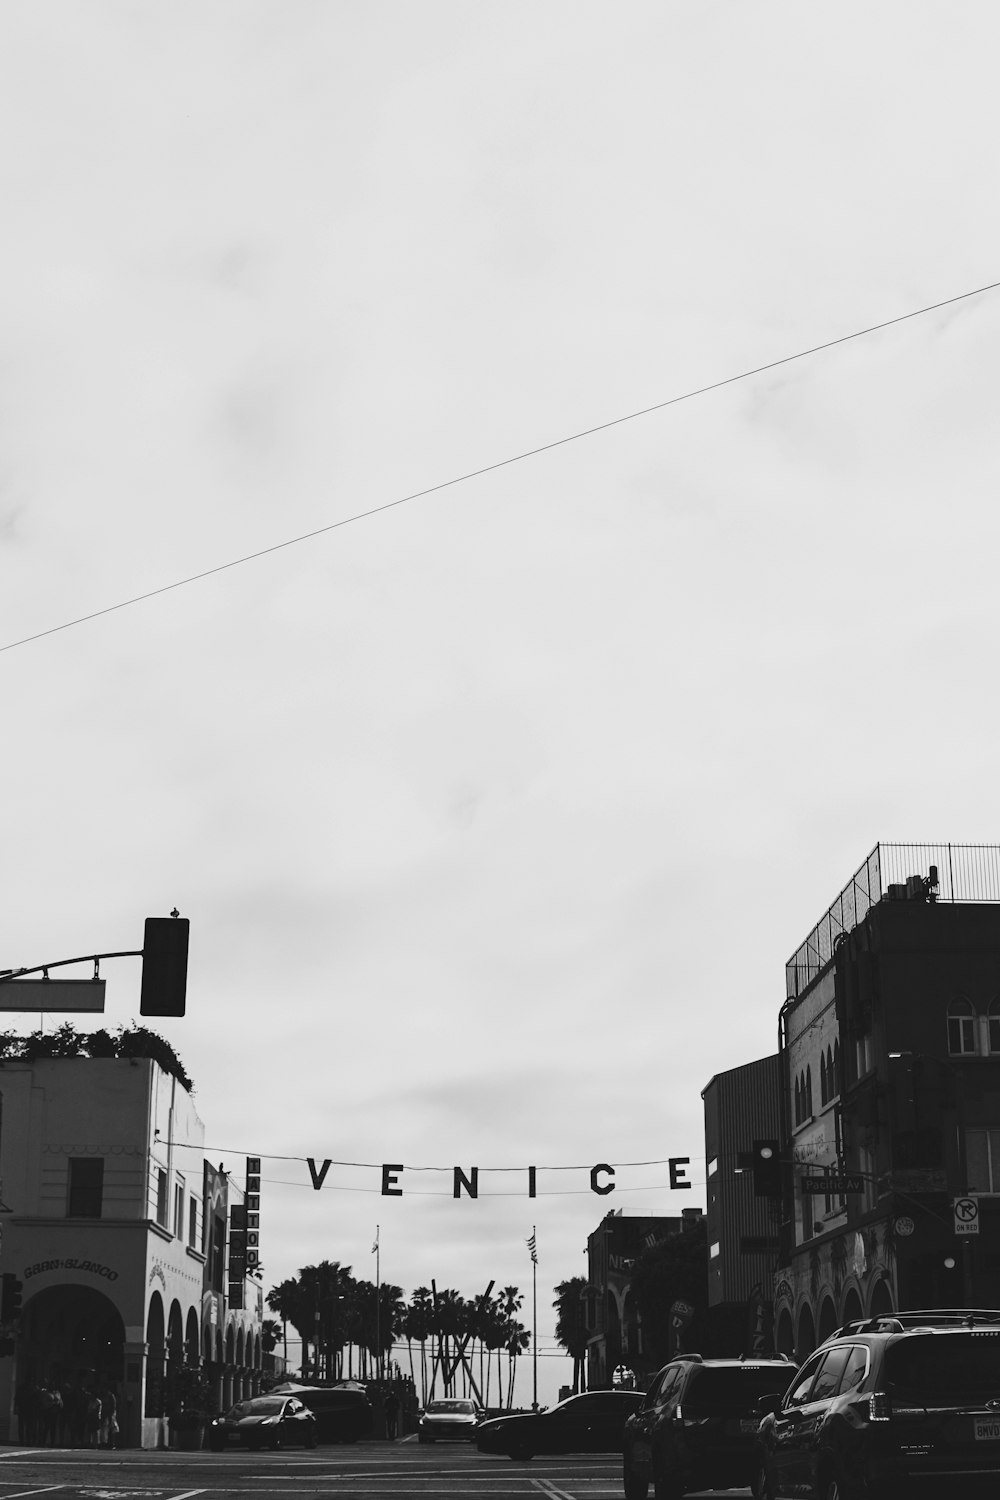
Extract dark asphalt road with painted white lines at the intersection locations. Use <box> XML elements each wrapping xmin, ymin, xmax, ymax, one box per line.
<box><xmin>0</xmin><ymin>1440</ymin><xmax>750</xmax><ymax>1500</ymax></box>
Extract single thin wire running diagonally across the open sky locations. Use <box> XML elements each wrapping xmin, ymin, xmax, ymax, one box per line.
<box><xmin>0</xmin><ymin>282</ymin><xmax>1000</xmax><ymax>651</ymax></box>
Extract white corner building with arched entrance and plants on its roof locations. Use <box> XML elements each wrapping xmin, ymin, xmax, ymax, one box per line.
<box><xmin>0</xmin><ymin>1058</ymin><xmax>262</xmax><ymax>1448</ymax></box>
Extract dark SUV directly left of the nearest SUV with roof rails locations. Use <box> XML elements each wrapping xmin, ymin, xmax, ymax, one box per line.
<box><xmin>622</xmin><ymin>1355</ymin><xmax>795</xmax><ymax>1500</ymax></box>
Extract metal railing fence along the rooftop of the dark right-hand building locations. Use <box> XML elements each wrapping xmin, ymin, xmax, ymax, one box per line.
<box><xmin>784</xmin><ymin>843</ymin><xmax>1000</xmax><ymax>1001</ymax></box>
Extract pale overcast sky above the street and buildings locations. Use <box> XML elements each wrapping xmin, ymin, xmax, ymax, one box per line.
<box><xmin>0</xmin><ymin>0</ymin><xmax>1000</xmax><ymax>1398</ymax></box>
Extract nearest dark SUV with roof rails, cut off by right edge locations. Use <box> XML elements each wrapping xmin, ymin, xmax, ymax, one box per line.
<box><xmin>754</xmin><ymin>1308</ymin><xmax>1000</xmax><ymax>1500</ymax></box>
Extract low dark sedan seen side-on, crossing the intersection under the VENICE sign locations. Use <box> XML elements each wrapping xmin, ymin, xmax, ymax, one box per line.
<box><xmin>475</xmin><ymin>1391</ymin><xmax>642</xmax><ymax>1458</ymax></box>
